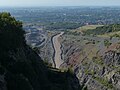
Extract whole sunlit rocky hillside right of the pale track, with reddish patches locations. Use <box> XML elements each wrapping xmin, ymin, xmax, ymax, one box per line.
<box><xmin>62</xmin><ymin>35</ymin><xmax>120</xmax><ymax>90</ymax></box>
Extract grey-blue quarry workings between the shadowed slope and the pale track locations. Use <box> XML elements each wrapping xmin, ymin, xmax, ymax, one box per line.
<box><xmin>23</xmin><ymin>24</ymin><xmax>54</xmax><ymax>64</ymax></box>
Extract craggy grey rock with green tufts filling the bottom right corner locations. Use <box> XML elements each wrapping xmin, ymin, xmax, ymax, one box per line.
<box><xmin>76</xmin><ymin>51</ymin><xmax>120</xmax><ymax>90</ymax></box>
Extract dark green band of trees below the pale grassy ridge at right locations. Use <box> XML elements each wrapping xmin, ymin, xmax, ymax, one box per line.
<box><xmin>84</xmin><ymin>24</ymin><xmax>120</xmax><ymax>35</ymax></box>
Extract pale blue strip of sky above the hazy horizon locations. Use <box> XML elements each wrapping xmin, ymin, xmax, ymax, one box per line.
<box><xmin>0</xmin><ymin>0</ymin><xmax>120</xmax><ymax>7</ymax></box>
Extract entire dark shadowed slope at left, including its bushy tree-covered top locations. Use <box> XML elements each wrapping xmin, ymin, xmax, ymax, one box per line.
<box><xmin>0</xmin><ymin>13</ymin><xmax>80</xmax><ymax>90</ymax></box>
